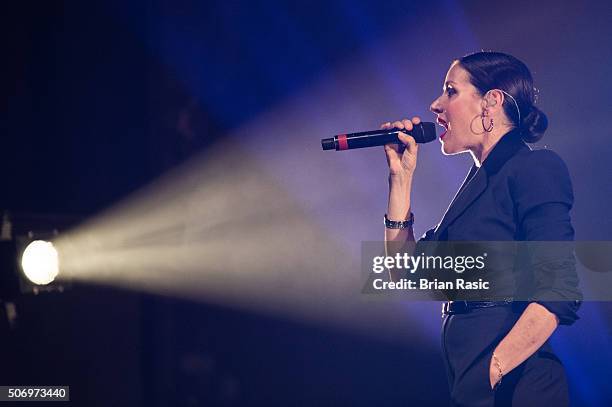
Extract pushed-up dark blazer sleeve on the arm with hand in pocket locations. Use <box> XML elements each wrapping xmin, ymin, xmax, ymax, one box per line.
<box><xmin>510</xmin><ymin>150</ymin><xmax>582</xmax><ymax>325</ymax></box>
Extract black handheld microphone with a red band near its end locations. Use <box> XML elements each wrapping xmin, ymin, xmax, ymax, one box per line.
<box><xmin>321</xmin><ymin>122</ymin><xmax>436</xmax><ymax>151</ymax></box>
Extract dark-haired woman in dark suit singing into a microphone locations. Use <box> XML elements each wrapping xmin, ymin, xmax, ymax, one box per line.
<box><xmin>382</xmin><ymin>52</ymin><xmax>580</xmax><ymax>406</ymax></box>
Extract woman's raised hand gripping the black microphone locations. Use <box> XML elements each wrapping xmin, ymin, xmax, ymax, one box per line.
<box><xmin>380</xmin><ymin>117</ymin><xmax>421</xmax><ymax>177</ymax></box>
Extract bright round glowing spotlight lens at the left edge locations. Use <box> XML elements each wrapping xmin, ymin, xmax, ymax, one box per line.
<box><xmin>21</xmin><ymin>240</ymin><xmax>59</xmax><ymax>285</ymax></box>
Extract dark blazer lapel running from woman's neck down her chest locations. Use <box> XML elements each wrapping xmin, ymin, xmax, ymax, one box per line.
<box><xmin>434</xmin><ymin>130</ymin><xmax>529</xmax><ymax>240</ymax></box>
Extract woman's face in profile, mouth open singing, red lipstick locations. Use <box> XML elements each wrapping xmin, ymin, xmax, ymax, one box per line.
<box><xmin>430</xmin><ymin>61</ymin><xmax>483</xmax><ymax>155</ymax></box>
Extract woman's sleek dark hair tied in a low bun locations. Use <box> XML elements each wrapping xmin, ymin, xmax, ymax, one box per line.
<box><xmin>459</xmin><ymin>51</ymin><xmax>548</xmax><ymax>143</ymax></box>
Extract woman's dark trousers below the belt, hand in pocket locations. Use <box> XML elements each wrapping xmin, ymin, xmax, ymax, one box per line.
<box><xmin>442</xmin><ymin>307</ymin><xmax>569</xmax><ymax>407</ymax></box>
